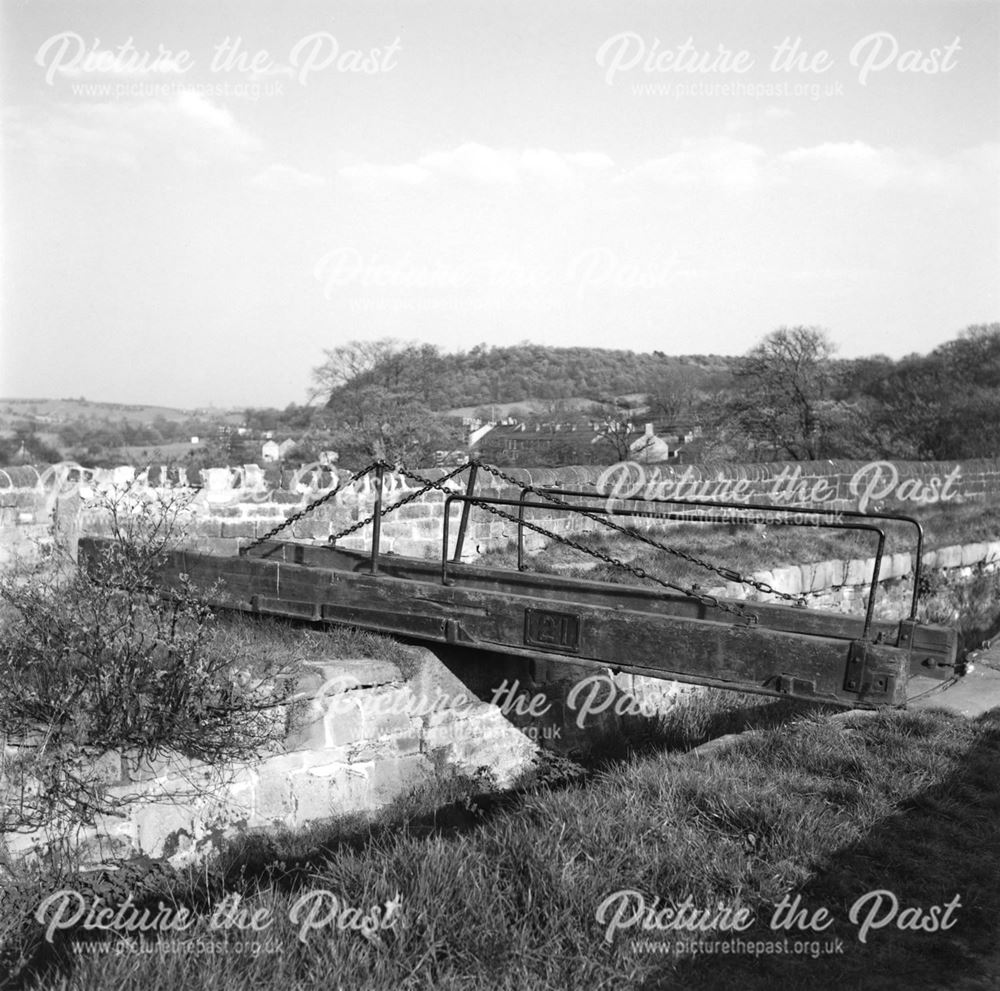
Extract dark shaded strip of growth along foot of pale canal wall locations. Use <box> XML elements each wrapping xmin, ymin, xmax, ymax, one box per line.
<box><xmin>0</xmin><ymin>690</ymin><xmax>818</xmax><ymax>991</ymax></box>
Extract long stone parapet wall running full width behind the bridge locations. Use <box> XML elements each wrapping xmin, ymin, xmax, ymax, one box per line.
<box><xmin>0</xmin><ymin>459</ymin><xmax>1000</xmax><ymax>568</ymax></box>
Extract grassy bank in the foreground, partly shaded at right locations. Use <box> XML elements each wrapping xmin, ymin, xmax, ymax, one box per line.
<box><xmin>6</xmin><ymin>700</ymin><xmax>1000</xmax><ymax>991</ymax></box>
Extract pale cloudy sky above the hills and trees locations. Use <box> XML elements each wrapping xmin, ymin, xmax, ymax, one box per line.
<box><xmin>0</xmin><ymin>0</ymin><xmax>1000</xmax><ymax>407</ymax></box>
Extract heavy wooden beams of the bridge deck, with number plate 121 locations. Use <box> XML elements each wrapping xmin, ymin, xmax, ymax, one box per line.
<box><xmin>81</xmin><ymin>538</ymin><xmax>957</xmax><ymax>708</ymax></box>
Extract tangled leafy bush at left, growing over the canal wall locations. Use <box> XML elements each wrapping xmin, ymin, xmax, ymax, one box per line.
<box><xmin>0</xmin><ymin>488</ymin><xmax>294</xmax><ymax>832</ymax></box>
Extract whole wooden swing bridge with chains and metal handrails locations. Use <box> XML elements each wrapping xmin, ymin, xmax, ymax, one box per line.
<box><xmin>80</xmin><ymin>461</ymin><xmax>962</xmax><ymax>708</ymax></box>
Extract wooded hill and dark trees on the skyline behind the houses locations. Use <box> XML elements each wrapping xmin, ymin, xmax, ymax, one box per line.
<box><xmin>311</xmin><ymin>323</ymin><xmax>1000</xmax><ymax>464</ymax></box>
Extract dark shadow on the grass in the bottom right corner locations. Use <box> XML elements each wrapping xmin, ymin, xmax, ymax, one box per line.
<box><xmin>642</xmin><ymin>709</ymin><xmax>1000</xmax><ymax>991</ymax></box>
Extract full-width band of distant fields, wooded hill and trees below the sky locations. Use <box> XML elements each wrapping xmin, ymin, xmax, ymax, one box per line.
<box><xmin>0</xmin><ymin>324</ymin><xmax>1000</xmax><ymax>469</ymax></box>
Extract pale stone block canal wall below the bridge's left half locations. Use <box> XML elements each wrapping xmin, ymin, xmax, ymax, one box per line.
<box><xmin>0</xmin><ymin>647</ymin><xmax>537</xmax><ymax>864</ymax></box>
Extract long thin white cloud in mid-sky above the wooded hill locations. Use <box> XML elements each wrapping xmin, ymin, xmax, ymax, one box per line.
<box><xmin>338</xmin><ymin>142</ymin><xmax>614</xmax><ymax>186</ymax></box>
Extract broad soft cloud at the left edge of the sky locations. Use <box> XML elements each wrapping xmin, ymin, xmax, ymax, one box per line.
<box><xmin>8</xmin><ymin>91</ymin><xmax>259</xmax><ymax>168</ymax></box>
